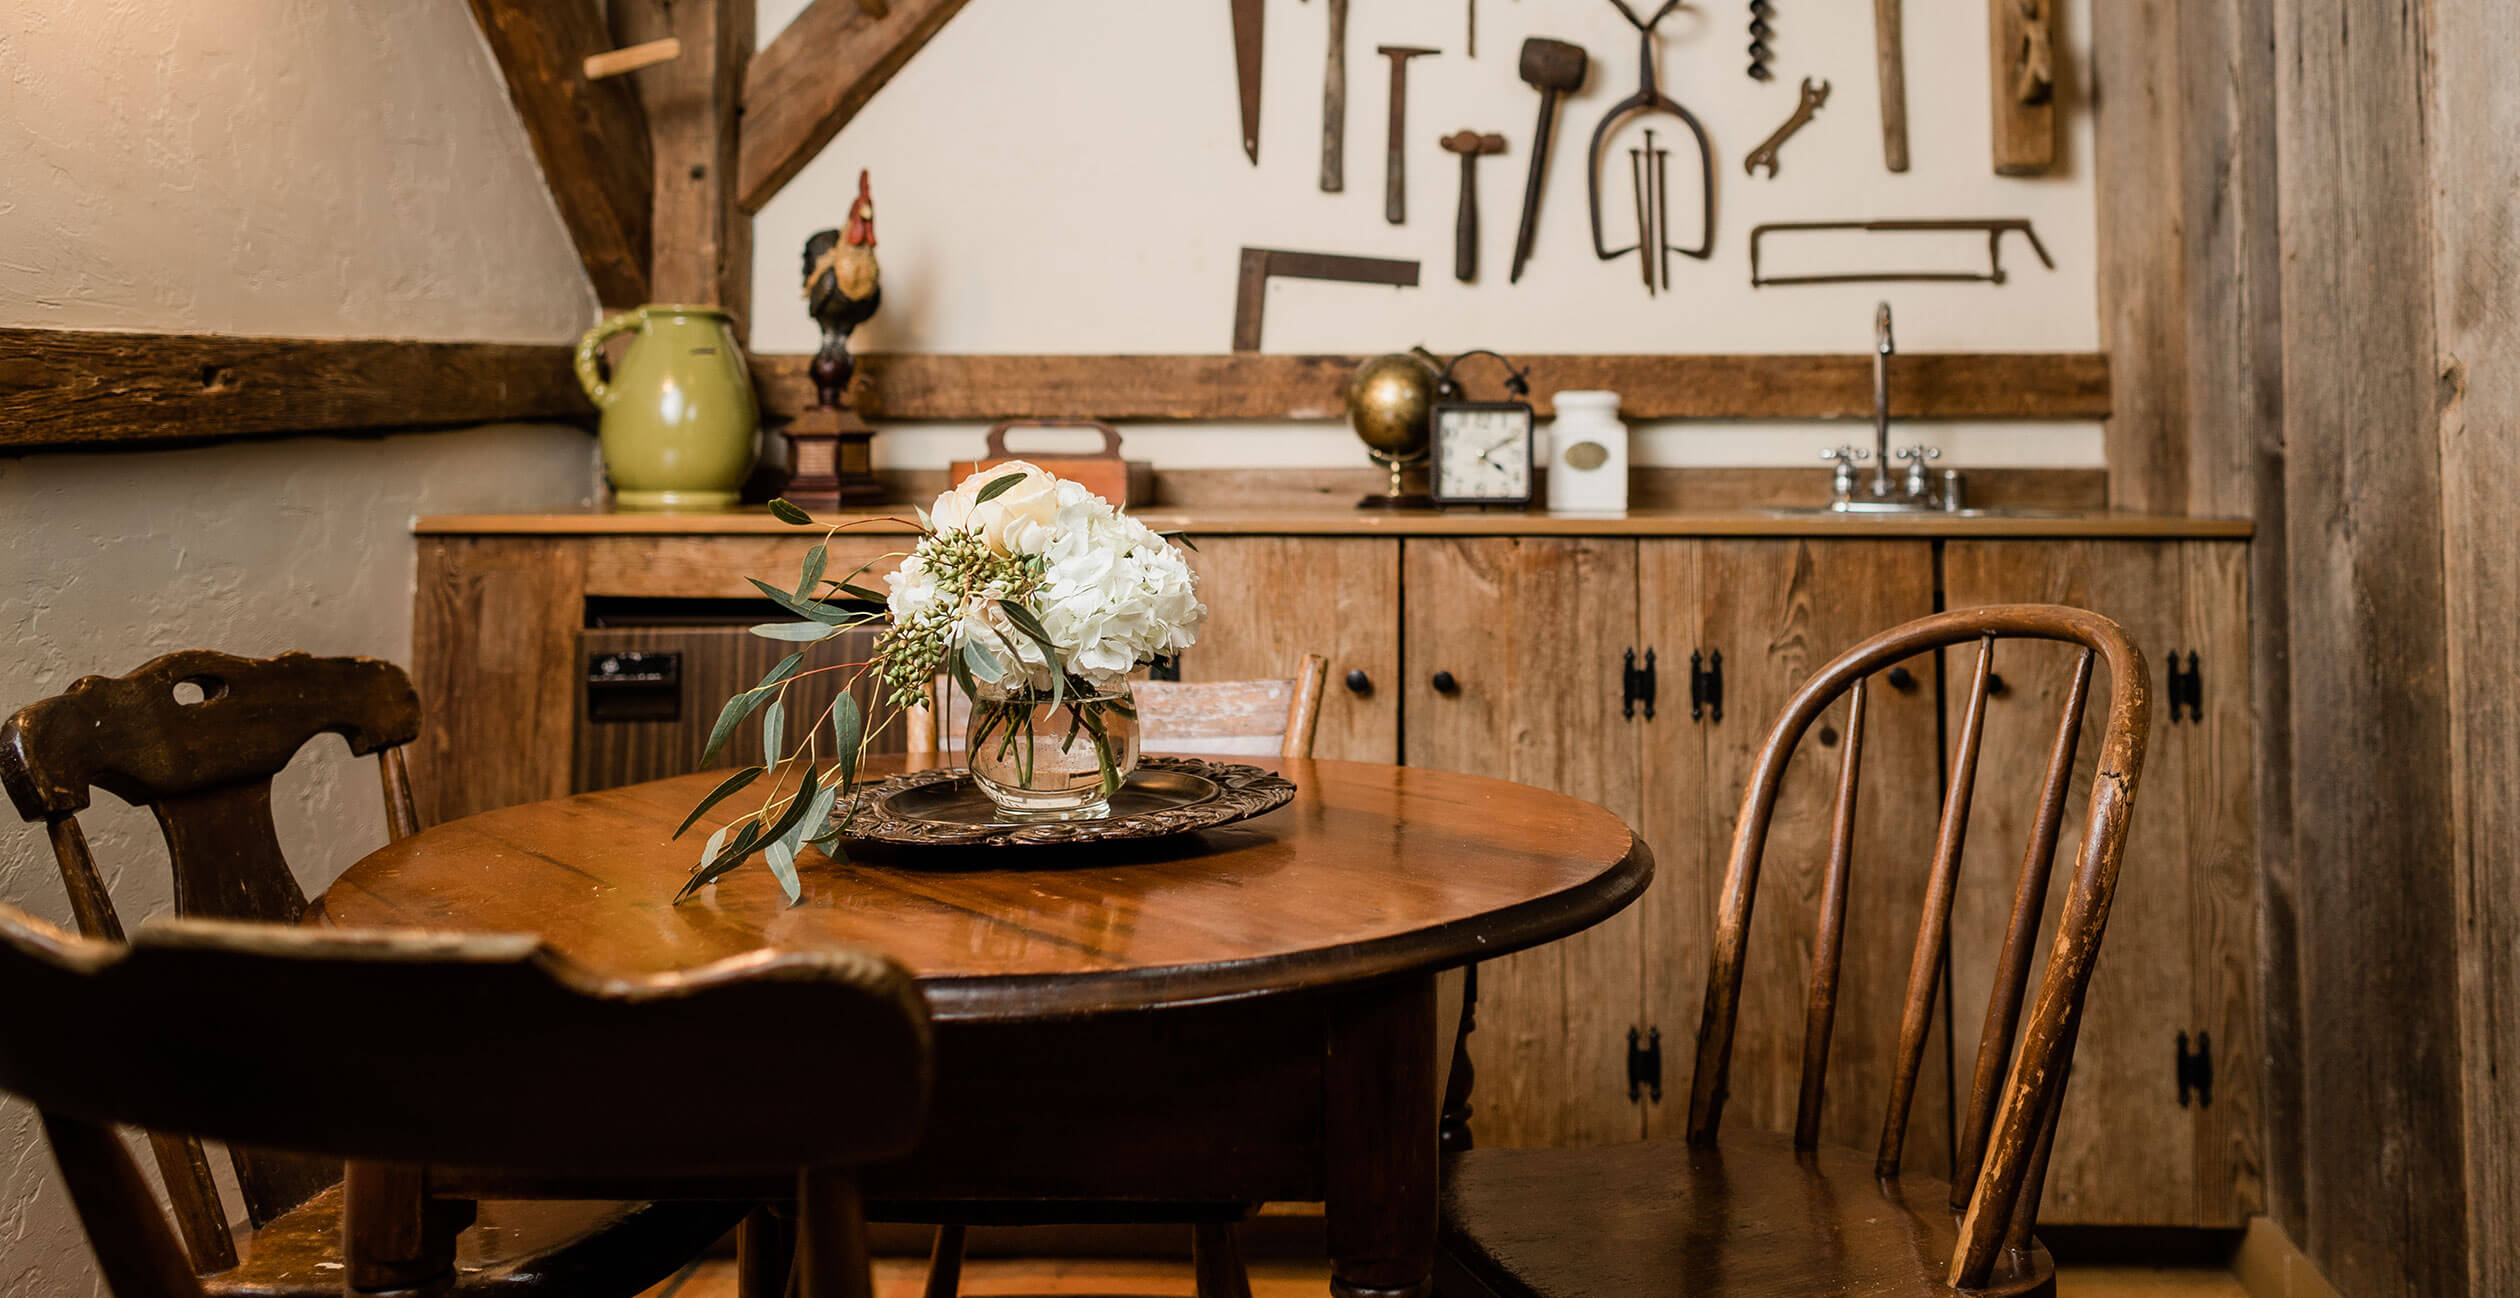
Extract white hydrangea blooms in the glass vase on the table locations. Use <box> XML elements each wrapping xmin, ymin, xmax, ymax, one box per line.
<box><xmin>890</xmin><ymin>461</ymin><xmax>1207</xmax><ymax>691</ymax></box>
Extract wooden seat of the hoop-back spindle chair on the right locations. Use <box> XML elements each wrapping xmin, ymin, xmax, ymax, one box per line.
<box><xmin>1436</xmin><ymin>1129</ymin><xmax>2056</xmax><ymax>1298</ymax></box>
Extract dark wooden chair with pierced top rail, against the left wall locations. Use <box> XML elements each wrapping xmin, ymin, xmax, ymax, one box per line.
<box><xmin>0</xmin><ymin>650</ymin><xmax>743</xmax><ymax>1295</ymax></box>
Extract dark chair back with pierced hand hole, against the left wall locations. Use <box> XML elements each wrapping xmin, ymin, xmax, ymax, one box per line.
<box><xmin>0</xmin><ymin>650</ymin><xmax>421</xmax><ymax>1240</ymax></box>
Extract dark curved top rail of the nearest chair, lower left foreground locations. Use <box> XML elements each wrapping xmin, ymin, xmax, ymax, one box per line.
<box><xmin>0</xmin><ymin>907</ymin><xmax>927</xmax><ymax>1177</ymax></box>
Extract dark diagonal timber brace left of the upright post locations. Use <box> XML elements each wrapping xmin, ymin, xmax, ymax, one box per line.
<box><xmin>469</xmin><ymin>0</ymin><xmax>655</xmax><ymax>307</ymax></box>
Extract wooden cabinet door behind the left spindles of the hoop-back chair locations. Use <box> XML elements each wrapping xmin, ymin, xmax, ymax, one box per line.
<box><xmin>1641</xmin><ymin>539</ymin><xmax>1950</xmax><ymax>1175</ymax></box>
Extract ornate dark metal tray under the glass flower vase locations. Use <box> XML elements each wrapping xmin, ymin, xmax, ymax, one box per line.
<box><xmin>832</xmin><ymin>756</ymin><xmax>1295</xmax><ymax>847</ymax></box>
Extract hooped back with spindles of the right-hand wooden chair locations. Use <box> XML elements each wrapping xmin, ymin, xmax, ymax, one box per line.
<box><xmin>1688</xmin><ymin>605</ymin><xmax>2152</xmax><ymax>1290</ymax></box>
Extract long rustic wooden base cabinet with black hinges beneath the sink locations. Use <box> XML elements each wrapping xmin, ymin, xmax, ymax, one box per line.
<box><xmin>413</xmin><ymin>512</ymin><xmax>2260</xmax><ymax>1227</ymax></box>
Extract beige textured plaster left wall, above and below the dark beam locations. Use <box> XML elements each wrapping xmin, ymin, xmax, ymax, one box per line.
<box><xmin>0</xmin><ymin>0</ymin><xmax>595</xmax><ymax>1298</ymax></box>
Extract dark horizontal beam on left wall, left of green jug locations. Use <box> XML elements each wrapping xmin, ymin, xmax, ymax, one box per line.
<box><xmin>0</xmin><ymin>328</ymin><xmax>595</xmax><ymax>454</ymax></box>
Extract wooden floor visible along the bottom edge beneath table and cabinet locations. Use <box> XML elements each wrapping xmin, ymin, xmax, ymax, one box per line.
<box><xmin>643</xmin><ymin>1258</ymin><xmax>2248</xmax><ymax>1298</ymax></box>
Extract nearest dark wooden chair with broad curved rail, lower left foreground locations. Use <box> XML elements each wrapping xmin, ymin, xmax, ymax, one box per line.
<box><xmin>0</xmin><ymin>907</ymin><xmax>930</xmax><ymax>1298</ymax></box>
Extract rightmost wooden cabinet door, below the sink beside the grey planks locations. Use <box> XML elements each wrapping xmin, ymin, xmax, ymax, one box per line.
<box><xmin>1943</xmin><ymin>542</ymin><xmax>2255</xmax><ymax>1225</ymax></box>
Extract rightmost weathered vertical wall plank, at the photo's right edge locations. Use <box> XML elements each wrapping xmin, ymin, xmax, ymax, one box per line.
<box><xmin>2429</xmin><ymin>0</ymin><xmax>2520</xmax><ymax>1295</ymax></box>
